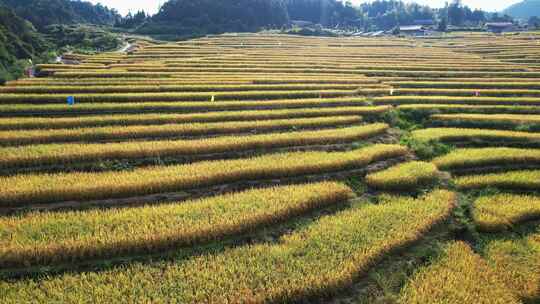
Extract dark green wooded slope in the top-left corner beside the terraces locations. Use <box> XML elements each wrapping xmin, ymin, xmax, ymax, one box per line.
<box><xmin>0</xmin><ymin>0</ymin><xmax>121</xmax><ymax>83</ymax></box>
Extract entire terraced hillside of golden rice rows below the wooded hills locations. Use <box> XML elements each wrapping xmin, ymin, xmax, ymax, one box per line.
<box><xmin>0</xmin><ymin>33</ymin><xmax>540</xmax><ymax>303</ymax></box>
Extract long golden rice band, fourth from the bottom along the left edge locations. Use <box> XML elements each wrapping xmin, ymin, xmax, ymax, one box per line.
<box><xmin>0</xmin><ymin>124</ymin><xmax>388</xmax><ymax>168</ymax></box>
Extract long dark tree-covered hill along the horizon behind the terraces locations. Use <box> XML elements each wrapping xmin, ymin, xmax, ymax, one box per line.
<box><xmin>137</xmin><ymin>0</ymin><xmax>503</xmax><ymax>39</ymax></box>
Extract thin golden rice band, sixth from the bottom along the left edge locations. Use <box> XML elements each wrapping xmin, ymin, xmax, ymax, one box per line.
<box><xmin>0</xmin><ymin>106</ymin><xmax>391</xmax><ymax>130</ymax></box>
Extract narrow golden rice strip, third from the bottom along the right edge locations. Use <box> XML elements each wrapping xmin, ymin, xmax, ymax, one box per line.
<box><xmin>454</xmin><ymin>170</ymin><xmax>540</xmax><ymax>191</ymax></box>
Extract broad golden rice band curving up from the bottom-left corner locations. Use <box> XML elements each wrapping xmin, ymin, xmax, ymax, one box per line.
<box><xmin>0</xmin><ymin>191</ymin><xmax>456</xmax><ymax>303</ymax></box>
